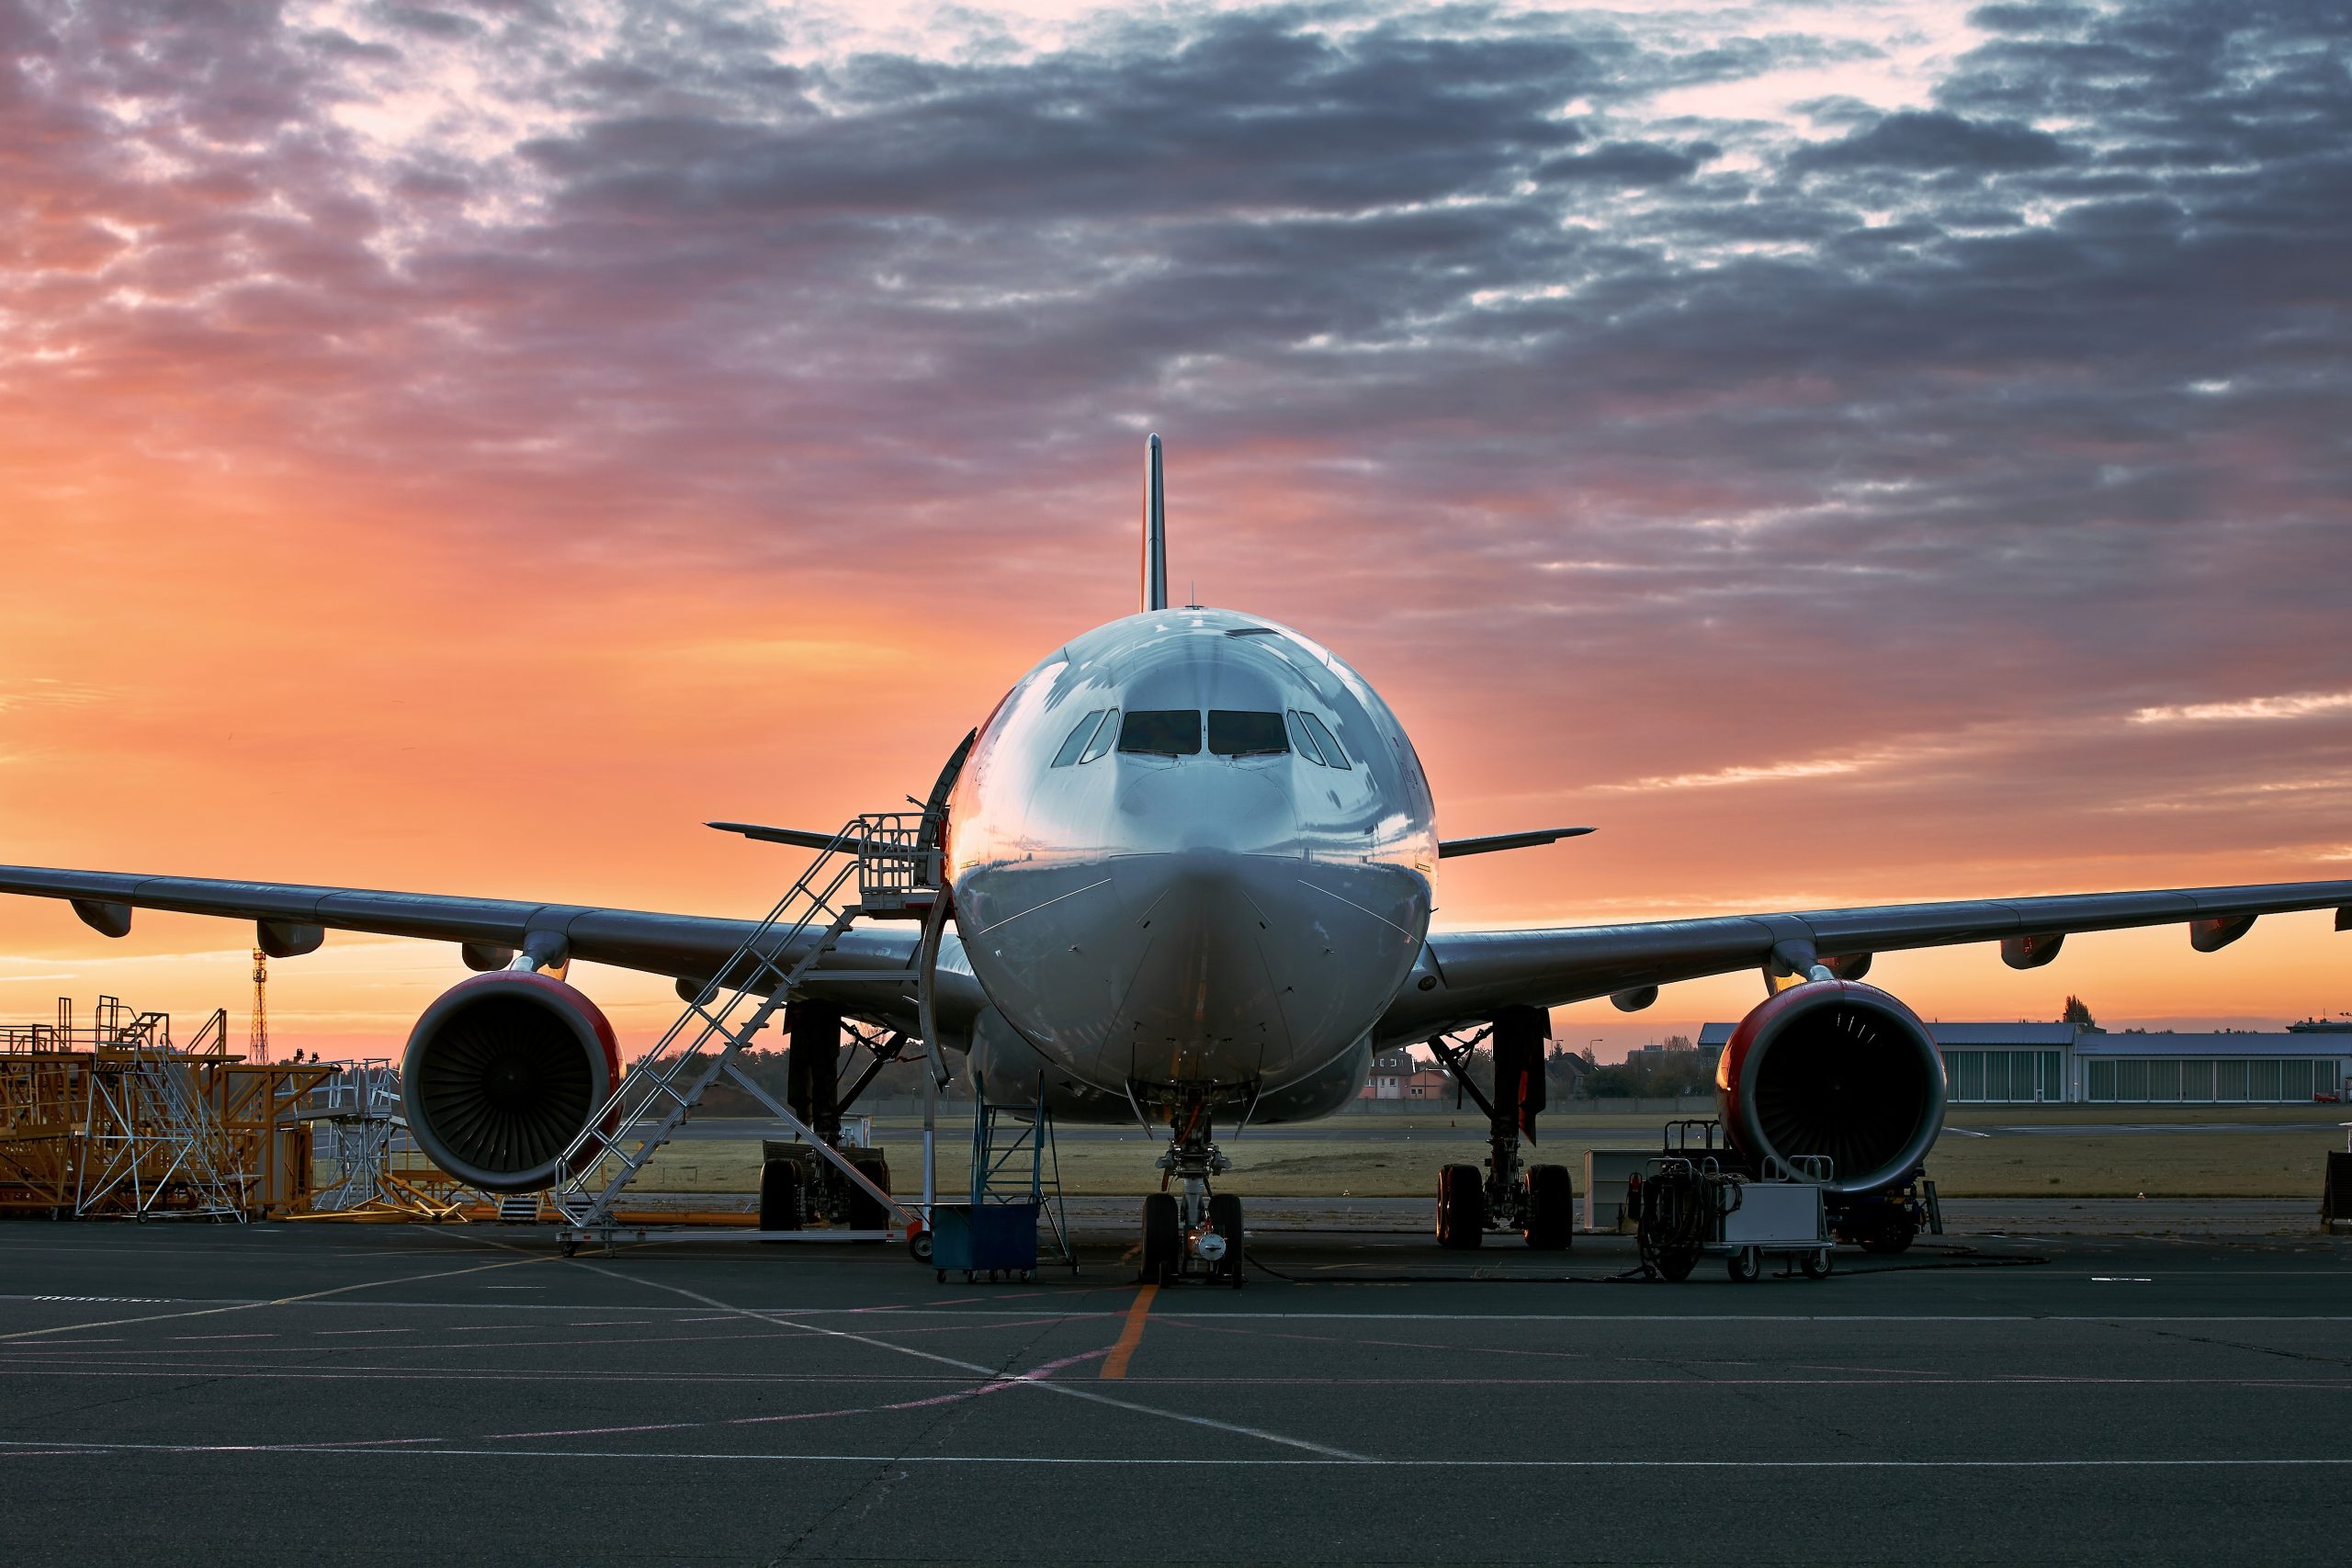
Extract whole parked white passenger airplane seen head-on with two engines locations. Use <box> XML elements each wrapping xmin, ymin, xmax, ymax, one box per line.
<box><xmin>0</xmin><ymin>434</ymin><xmax>2352</xmax><ymax>1283</ymax></box>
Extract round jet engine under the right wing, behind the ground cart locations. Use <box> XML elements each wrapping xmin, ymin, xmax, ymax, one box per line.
<box><xmin>1714</xmin><ymin>980</ymin><xmax>1943</xmax><ymax>1194</ymax></box>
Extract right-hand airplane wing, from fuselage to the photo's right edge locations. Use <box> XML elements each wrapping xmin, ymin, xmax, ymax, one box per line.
<box><xmin>1376</xmin><ymin>882</ymin><xmax>2352</xmax><ymax>1043</ymax></box>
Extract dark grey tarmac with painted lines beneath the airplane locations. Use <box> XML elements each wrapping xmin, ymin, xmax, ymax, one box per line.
<box><xmin>0</xmin><ymin>1201</ymin><xmax>2352</xmax><ymax>1568</ymax></box>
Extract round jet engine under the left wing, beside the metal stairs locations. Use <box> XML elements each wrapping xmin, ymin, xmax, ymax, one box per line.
<box><xmin>400</xmin><ymin>968</ymin><xmax>621</xmax><ymax>1192</ymax></box>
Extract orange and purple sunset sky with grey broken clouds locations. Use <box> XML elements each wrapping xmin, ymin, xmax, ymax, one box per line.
<box><xmin>0</xmin><ymin>0</ymin><xmax>2352</xmax><ymax>1058</ymax></box>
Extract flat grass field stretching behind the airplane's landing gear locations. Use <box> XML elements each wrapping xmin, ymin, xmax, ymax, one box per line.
<box><xmin>638</xmin><ymin>1105</ymin><xmax>2347</xmax><ymax>1201</ymax></box>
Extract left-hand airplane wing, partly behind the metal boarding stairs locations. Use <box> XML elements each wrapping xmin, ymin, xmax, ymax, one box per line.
<box><xmin>0</xmin><ymin>865</ymin><xmax>945</xmax><ymax>1022</ymax></box>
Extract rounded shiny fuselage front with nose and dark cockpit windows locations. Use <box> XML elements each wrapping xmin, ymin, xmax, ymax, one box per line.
<box><xmin>948</xmin><ymin>609</ymin><xmax>1437</xmax><ymax>1107</ymax></box>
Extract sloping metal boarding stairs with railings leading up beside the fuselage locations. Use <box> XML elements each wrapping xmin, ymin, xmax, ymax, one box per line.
<box><xmin>548</xmin><ymin>811</ymin><xmax>938</xmax><ymax>1251</ymax></box>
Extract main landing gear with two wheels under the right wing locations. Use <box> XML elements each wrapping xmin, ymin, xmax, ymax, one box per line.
<box><xmin>1430</xmin><ymin>1006</ymin><xmax>1576</xmax><ymax>1253</ymax></box>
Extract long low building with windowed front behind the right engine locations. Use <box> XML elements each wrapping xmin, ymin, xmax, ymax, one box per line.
<box><xmin>1698</xmin><ymin>1021</ymin><xmax>2352</xmax><ymax>1105</ymax></box>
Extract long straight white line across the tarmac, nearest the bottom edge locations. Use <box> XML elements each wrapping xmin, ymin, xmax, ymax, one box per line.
<box><xmin>0</xmin><ymin>1438</ymin><xmax>2352</xmax><ymax>1472</ymax></box>
